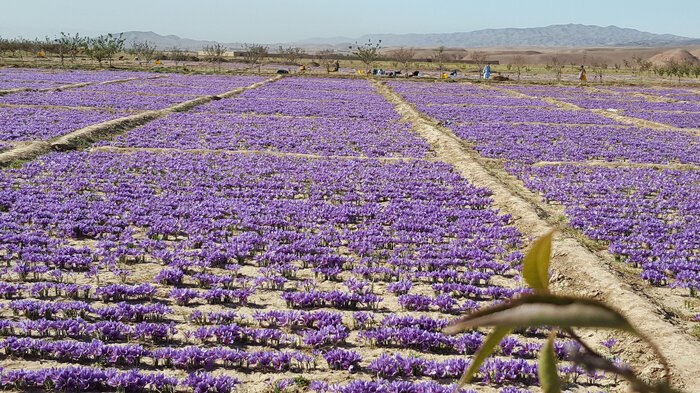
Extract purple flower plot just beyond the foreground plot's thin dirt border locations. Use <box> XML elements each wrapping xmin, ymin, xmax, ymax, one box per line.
<box><xmin>101</xmin><ymin>111</ymin><xmax>429</xmax><ymax>157</ymax></box>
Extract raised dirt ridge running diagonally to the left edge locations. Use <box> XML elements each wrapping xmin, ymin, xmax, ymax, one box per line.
<box><xmin>0</xmin><ymin>75</ymin><xmax>281</xmax><ymax>167</ymax></box>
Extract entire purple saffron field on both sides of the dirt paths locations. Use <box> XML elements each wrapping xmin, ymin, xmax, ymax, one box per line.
<box><xmin>0</xmin><ymin>69</ymin><xmax>700</xmax><ymax>393</ymax></box>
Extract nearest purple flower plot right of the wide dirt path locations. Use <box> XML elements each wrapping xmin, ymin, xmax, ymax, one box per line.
<box><xmin>511</xmin><ymin>165</ymin><xmax>700</xmax><ymax>292</ymax></box>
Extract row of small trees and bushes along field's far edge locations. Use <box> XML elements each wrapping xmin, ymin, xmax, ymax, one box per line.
<box><xmin>0</xmin><ymin>32</ymin><xmax>700</xmax><ymax>81</ymax></box>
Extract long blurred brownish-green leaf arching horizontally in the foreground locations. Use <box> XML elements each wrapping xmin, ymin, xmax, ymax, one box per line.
<box><xmin>443</xmin><ymin>294</ymin><xmax>636</xmax><ymax>334</ymax></box>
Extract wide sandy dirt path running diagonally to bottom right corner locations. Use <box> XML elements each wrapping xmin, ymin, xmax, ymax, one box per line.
<box><xmin>374</xmin><ymin>82</ymin><xmax>700</xmax><ymax>391</ymax></box>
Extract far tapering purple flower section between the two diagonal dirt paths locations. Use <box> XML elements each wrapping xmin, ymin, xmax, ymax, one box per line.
<box><xmin>104</xmin><ymin>79</ymin><xmax>429</xmax><ymax>157</ymax></box>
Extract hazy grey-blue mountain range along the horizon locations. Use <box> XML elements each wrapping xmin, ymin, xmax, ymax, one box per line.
<box><xmin>124</xmin><ymin>24</ymin><xmax>700</xmax><ymax>51</ymax></box>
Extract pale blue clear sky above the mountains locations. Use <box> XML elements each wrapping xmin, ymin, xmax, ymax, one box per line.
<box><xmin>0</xmin><ymin>0</ymin><xmax>700</xmax><ymax>43</ymax></box>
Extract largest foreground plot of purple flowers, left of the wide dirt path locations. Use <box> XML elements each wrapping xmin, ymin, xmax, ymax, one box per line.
<box><xmin>0</xmin><ymin>152</ymin><xmax>616</xmax><ymax>392</ymax></box>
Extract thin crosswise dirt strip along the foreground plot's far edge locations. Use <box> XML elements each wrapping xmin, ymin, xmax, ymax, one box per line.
<box><xmin>90</xmin><ymin>146</ymin><xmax>436</xmax><ymax>162</ymax></box>
